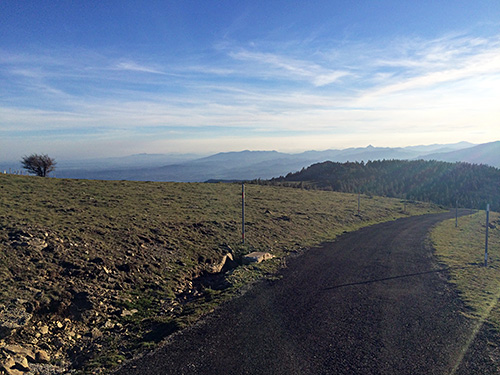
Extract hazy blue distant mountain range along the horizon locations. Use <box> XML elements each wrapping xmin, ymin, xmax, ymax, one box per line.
<box><xmin>0</xmin><ymin>141</ymin><xmax>500</xmax><ymax>182</ymax></box>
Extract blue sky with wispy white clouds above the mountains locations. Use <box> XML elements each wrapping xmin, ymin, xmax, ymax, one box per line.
<box><xmin>0</xmin><ymin>0</ymin><xmax>500</xmax><ymax>161</ymax></box>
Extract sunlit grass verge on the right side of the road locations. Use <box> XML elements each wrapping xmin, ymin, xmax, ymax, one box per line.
<box><xmin>431</xmin><ymin>211</ymin><xmax>500</xmax><ymax>330</ymax></box>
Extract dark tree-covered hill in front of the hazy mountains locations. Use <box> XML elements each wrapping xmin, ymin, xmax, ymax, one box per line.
<box><xmin>271</xmin><ymin>160</ymin><xmax>500</xmax><ymax>210</ymax></box>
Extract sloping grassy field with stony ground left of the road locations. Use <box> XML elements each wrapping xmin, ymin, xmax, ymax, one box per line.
<box><xmin>0</xmin><ymin>175</ymin><xmax>439</xmax><ymax>373</ymax></box>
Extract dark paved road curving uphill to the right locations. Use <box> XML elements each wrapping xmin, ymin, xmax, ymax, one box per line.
<box><xmin>115</xmin><ymin>214</ymin><xmax>500</xmax><ymax>375</ymax></box>
